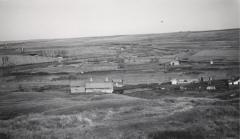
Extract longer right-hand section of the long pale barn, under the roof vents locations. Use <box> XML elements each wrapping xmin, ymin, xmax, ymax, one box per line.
<box><xmin>85</xmin><ymin>82</ymin><xmax>113</xmax><ymax>93</ymax></box>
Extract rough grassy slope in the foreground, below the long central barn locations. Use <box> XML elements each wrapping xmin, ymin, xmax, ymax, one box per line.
<box><xmin>0</xmin><ymin>90</ymin><xmax>239</xmax><ymax>139</ymax></box>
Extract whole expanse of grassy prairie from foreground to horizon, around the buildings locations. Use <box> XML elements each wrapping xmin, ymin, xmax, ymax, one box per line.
<box><xmin>0</xmin><ymin>29</ymin><xmax>240</xmax><ymax>139</ymax></box>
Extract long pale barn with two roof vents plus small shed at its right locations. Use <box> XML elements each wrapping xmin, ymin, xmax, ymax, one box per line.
<box><xmin>70</xmin><ymin>78</ymin><xmax>123</xmax><ymax>94</ymax></box>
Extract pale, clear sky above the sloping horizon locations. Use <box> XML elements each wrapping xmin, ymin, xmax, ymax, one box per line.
<box><xmin>0</xmin><ymin>0</ymin><xmax>240</xmax><ymax>41</ymax></box>
